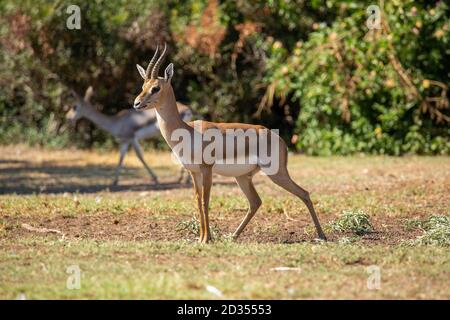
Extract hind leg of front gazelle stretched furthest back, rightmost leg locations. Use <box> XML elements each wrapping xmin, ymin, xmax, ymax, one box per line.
<box><xmin>268</xmin><ymin>167</ymin><xmax>327</xmax><ymax>240</ymax></box>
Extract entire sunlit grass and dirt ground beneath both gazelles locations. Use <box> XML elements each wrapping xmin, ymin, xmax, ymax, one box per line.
<box><xmin>0</xmin><ymin>146</ymin><xmax>450</xmax><ymax>299</ymax></box>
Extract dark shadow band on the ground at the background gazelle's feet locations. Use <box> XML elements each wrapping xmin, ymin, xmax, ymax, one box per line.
<box><xmin>0</xmin><ymin>160</ymin><xmax>190</xmax><ymax>195</ymax></box>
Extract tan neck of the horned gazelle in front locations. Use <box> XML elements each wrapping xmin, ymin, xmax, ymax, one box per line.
<box><xmin>156</xmin><ymin>86</ymin><xmax>192</xmax><ymax>148</ymax></box>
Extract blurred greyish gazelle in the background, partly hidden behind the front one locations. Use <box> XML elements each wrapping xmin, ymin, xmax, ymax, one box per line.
<box><xmin>66</xmin><ymin>86</ymin><xmax>192</xmax><ymax>185</ymax></box>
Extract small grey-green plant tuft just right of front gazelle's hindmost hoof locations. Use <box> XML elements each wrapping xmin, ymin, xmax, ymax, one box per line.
<box><xmin>329</xmin><ymin>210</ymin><xmax>374</xmax><ymax>235</ymax></box>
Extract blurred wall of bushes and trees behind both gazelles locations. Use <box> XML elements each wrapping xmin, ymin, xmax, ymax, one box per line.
<box><xmin>0</xmin><ymin>0</ymin><xmax>450</xmax><ymax>155</ymax></box>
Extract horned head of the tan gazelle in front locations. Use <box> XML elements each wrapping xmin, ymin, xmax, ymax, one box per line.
<box><xmin>134</xmin><ymin>44</ymin><xmax>173</xmax><ymax>110</ymax></box>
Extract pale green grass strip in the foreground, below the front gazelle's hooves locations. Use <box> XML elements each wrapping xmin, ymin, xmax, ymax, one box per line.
<box><xmin>0</xmin><ymin>238</ymin><xmax>449</xmax><ymax>299</ymax></box>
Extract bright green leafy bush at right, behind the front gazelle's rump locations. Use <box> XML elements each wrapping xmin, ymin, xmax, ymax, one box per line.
<box><xmin>263</xmin><ymin>1</ymin><xmax>450</xmax><ymax>155</ymax></box>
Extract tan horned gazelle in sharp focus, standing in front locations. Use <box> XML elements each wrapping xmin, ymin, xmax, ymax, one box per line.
<box><xmin>134</xmin><ymin>43</ymin><xmax>326</xmax><ymax>243</ymax></box>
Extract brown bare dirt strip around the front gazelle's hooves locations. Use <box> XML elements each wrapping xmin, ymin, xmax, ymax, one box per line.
<box><xmin>3</xmin><ymin>211</ymin><xmax>421</xmax><ymax>245</ymax></box>
